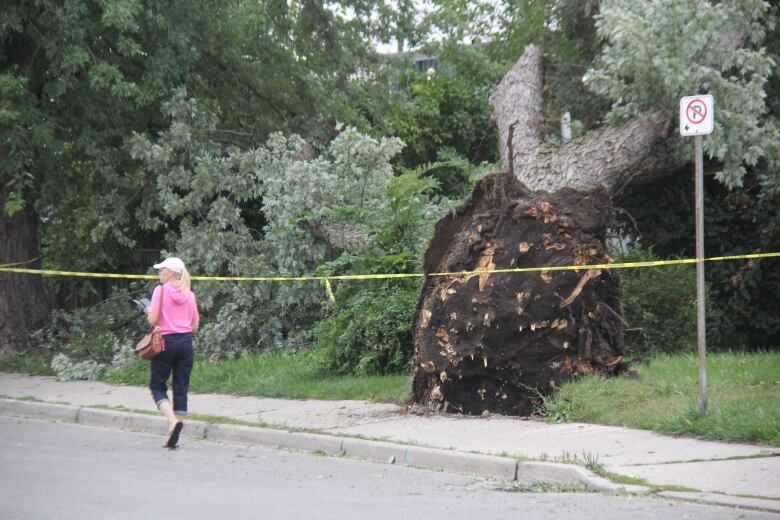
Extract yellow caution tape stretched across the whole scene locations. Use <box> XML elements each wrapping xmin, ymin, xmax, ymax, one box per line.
<box><xmin>0</xmin><ymin>252</ymin><xmax>780</xmax><ymax>282</ymax></box>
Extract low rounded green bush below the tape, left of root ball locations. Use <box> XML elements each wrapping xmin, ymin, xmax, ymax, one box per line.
<box><xmin>314</xmin><ymin>282</ymin><xmax>420</xmax><ymax>375</ymax></box>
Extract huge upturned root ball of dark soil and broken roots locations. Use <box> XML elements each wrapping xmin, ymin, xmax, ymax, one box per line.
<box><xmin>412</xmin><ymin>173</ymin><xmax>623</xmax><ymax>415</ymax></box>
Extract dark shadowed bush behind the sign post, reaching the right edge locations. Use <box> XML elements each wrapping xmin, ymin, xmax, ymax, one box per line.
<box><xmin>615</xmin><ymin>168</ymin><xmax>780</xmax><ymax>350</ymax></box>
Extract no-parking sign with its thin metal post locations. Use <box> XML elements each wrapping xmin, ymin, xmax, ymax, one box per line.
<box><xmin>680</xmin><ymin>95</ymin><xmax>714</xmax><ymax>414</ymax></box>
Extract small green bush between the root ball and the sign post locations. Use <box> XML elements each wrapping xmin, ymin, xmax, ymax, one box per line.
<box><xmin>617</xmin><ymin>248</ymin><xmax>717</xmax><ymax>356</ymax></box>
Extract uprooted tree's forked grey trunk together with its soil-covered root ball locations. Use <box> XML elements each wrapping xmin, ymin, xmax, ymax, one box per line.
<box><xmin>412</xmin><ymin>46</ymin><xmax>675</xmax><ymax>415</ymax></box>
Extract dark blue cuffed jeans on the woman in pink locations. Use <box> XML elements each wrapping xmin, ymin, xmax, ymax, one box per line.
<box><xmin>149</xmin><ymin>332</ymin><xmax>195</xmax><ymax>415</ymax></box>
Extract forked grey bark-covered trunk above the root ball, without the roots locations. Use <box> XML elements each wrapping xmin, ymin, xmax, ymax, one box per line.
<box><xmin>492</xmin><ymin>45</ymin><xmax>679</xmax><ymax>194</ymax></box>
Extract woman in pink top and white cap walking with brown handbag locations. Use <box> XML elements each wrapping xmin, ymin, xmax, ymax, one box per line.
<box><xmin>147</xmin><ymin>257</ymin><xmax>200</xmax><ymax>448</ymax></box>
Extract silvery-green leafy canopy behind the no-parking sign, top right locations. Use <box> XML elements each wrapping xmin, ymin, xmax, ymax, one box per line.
<box><xmin>586</xmin><ymin>0</ymin><xmax>780</xmax><ymax>187</ymax></box>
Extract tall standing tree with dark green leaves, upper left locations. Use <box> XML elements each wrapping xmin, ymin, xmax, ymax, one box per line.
<box><xmin>0</xmin><ymin>0</ymin><xmax>378</xmax><ymax>353</ymax></box>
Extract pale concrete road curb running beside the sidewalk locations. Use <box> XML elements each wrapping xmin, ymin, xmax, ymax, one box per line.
<box><xmin>0</xmin><ymin>398</ymin><xmax>648</xmax><ymax>493</ymax></box>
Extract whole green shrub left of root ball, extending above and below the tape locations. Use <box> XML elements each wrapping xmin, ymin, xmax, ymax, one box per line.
<box><xmin>314</xmin><ymin>165</ymin><xmax>447</xmax><ymax>376</ymax></box>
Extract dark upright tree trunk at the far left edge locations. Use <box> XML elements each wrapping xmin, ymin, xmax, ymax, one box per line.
<box><xmin>0</xmin><ymin>147</ymin><xmax>49</xmax><ymax>359</ymax></box>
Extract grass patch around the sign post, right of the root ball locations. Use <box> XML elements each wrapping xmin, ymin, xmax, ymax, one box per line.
<box><xmin>545</xmin><ymin>353</ymin><xmax>780</xmax><ymax>446</ymax></box>
